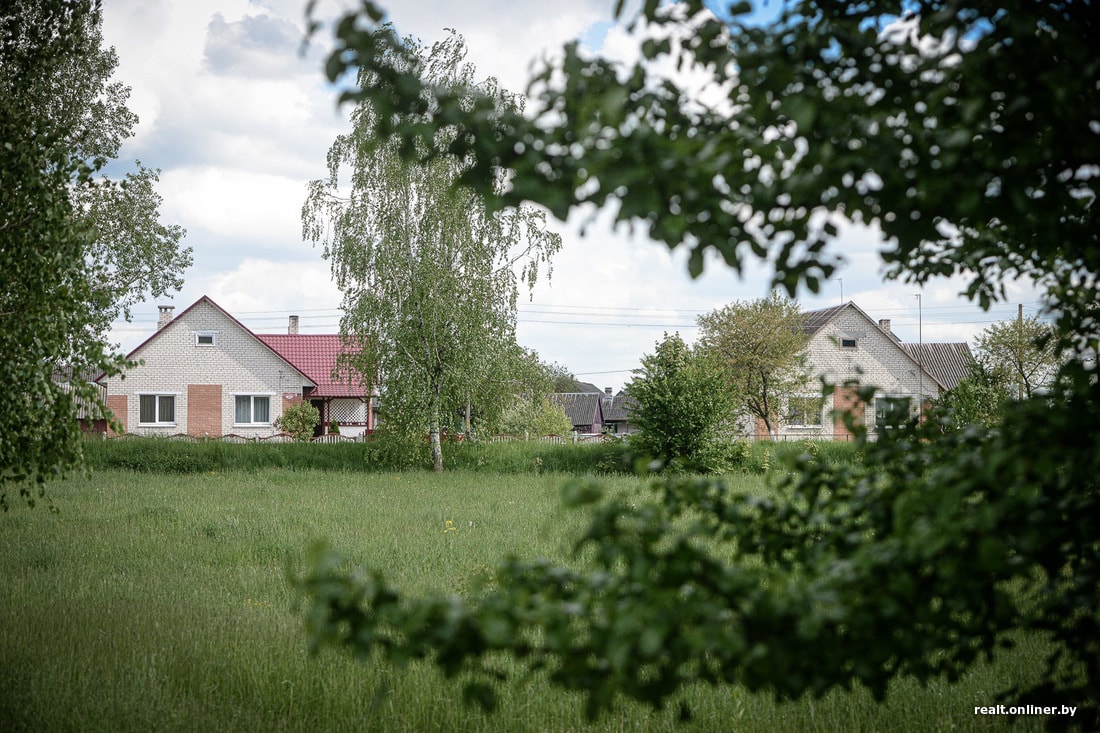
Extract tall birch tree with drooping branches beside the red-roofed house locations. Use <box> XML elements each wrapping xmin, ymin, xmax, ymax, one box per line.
<box><xmin>303</xmin><ymin>34</ymin><xmax>561</xmax><ymax>471</ymax></box>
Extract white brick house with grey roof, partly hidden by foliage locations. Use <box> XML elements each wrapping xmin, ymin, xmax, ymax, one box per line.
<box><xmin>756</xmin><ymin>303</ymin><xmax>974</xmax><ymax>440</ymax></box>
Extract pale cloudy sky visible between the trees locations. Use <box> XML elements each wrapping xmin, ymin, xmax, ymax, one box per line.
<box><xmin>103</xmin><ymin>0</ymin><xmax>1040</xmax><ymax>391</ymax></box>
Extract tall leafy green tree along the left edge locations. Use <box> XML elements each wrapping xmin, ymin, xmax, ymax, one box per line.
<box><xmin>0</xmin><ymin>0</ymin><xmax>187</xmax><ymax>501</ymax></box>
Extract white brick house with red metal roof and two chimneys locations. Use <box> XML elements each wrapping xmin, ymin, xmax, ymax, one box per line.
<box><xmin>98</xmin><ymin>296</ymin><xmax>374</xmax><ymax>438</ymax></box>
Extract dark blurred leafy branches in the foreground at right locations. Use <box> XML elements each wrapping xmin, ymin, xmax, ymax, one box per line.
<box><xmin>297</xmin><ymin>0</ymin><xmax>1100</xmax><ymax>727</ymax></box>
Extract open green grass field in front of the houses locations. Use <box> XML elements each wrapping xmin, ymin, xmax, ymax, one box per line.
<box><xmin>0</xmin><ymin>469</ymin><xmax>1044</xmax><ymax>732</ymax></box>
